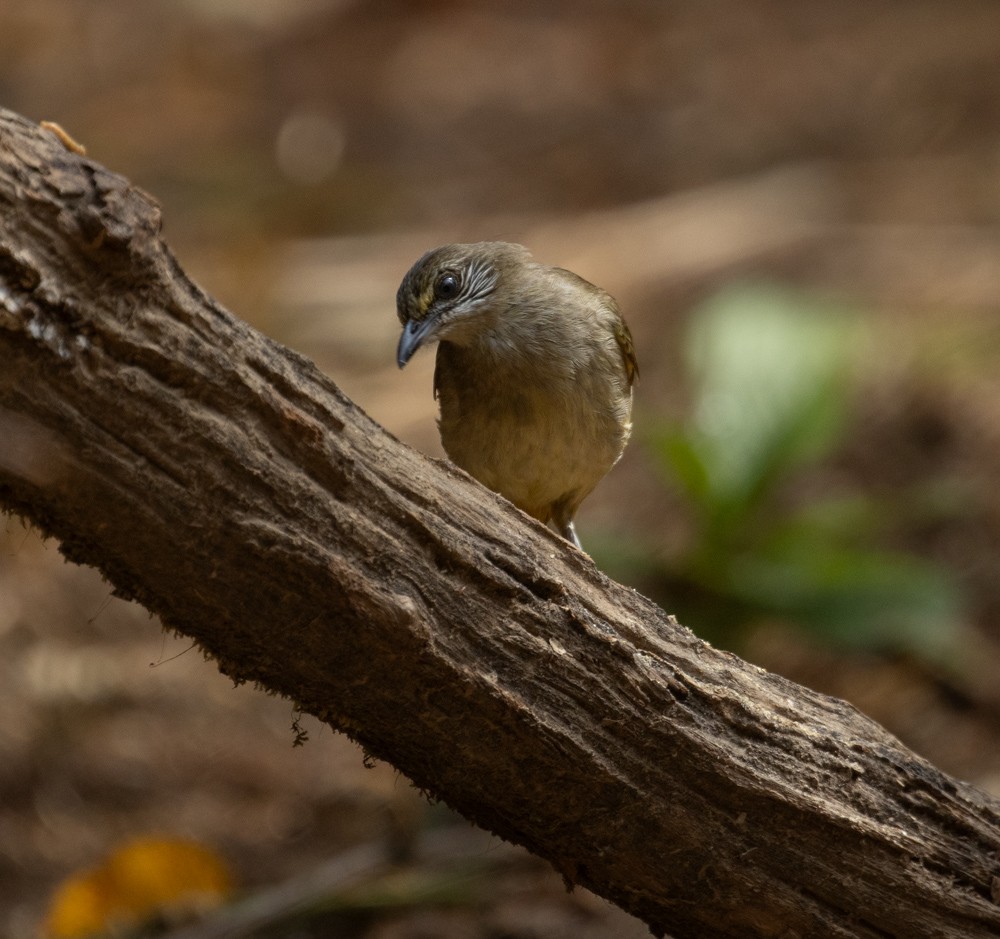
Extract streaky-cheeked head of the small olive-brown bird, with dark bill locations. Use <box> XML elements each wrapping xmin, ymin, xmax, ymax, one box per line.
<box><xmin>396</xmin><ymin>241</ymin><xmax>531</xmax><ymax>368</ymax></box>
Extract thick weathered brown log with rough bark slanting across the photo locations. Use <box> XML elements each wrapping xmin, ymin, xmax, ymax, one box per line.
<box><xmin>0</xmin><ymin>106</ymin><xmax>1000</xmax><ymax>939</ymax></box>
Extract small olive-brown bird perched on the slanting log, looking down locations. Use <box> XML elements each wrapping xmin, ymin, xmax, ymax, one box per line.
<box><xmin>396</xmin><ymin>241</ymin><xmax>639</xmax><ymax>550</ymax></box>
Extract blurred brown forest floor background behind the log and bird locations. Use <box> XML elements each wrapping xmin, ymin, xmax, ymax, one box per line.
<box><xmin>0</xmin><ymin>0</ymin><xmax>1000</xmax><ymax>939</ymax></box>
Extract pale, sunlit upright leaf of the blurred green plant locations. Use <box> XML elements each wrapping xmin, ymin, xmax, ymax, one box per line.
<box><xmin>686</xmin><ymin>286</ymin><xmax>858</xmax><ymax>509</ymax></box>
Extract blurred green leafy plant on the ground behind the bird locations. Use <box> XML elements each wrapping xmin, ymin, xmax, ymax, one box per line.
<box><xmin>649</xmin><ymin>285</ymin><xmax>960</xmax><ymax>657</ymax></box>
